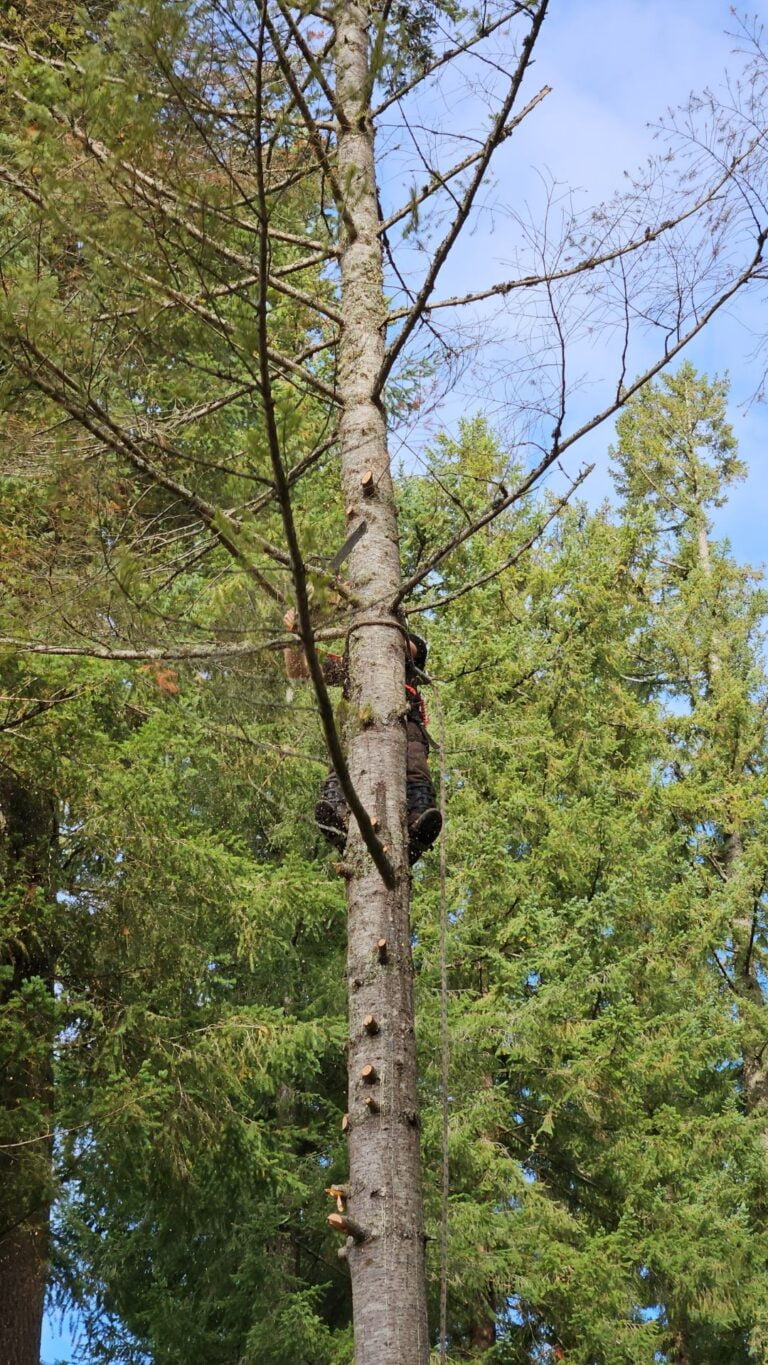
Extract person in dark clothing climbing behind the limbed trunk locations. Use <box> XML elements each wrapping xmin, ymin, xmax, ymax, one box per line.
<box><xmin>284</xmin><ymin>607</ymin><xmax>442</xmax><ymax>865</ymax></box>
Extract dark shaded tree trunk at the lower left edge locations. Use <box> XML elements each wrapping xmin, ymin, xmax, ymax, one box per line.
<box><xmin>0</xmin><ymin>775</ymin><xmax>56</xmax><ymax>1365</ymax></box>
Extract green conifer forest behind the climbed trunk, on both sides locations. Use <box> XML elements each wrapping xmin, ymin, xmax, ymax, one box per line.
<box><xmin>0</xmin><ymin>4</ymin><xmax>768</xmax><ymax>1365</ymax></box>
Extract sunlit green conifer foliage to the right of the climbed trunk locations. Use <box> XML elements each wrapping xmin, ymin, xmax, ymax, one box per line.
<box><xmin>405</xmin><ymin>387</ymin><xmax>768</xmax><ymax>1365</ymax></box>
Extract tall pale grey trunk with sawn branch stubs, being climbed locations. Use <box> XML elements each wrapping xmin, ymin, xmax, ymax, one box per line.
<box><xmin>336</xmin><ymin>3</ymin><xmax>430</xmax><ymax>1365</ymax></box>
